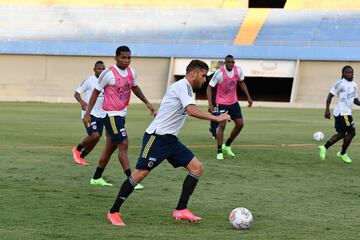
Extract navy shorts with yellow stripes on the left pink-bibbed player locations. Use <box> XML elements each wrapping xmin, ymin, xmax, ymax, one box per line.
<box><xmin>103</xmin><ymin>115</ymin><xmax>127</xmax><ymax>144</ymax></box>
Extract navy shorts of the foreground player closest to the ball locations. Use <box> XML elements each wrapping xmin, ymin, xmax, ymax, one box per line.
<box><xmin>136</xmin><ymin>133</ymin><xmax>194</xmax><ymax>171</ymax></box>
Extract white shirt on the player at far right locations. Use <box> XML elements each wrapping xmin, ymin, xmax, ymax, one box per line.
<box><xmin>330</xmin><ymin>78</ymin><xmax>358</xmax><ymax>116</ymax></box>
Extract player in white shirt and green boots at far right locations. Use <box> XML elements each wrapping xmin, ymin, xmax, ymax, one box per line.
<box><xmin>319</xmin><ymin>66</ymin><xmax>360</xmax><ymax>163</ymax></box>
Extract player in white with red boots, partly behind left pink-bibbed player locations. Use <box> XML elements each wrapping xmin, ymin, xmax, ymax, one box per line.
<box><xmin>72</xmin><ymin>61</ymin><xmax>106</xmax><ymax>165</ymax></box>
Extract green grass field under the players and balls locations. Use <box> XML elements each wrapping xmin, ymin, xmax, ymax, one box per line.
<box><xmin>0</xmin><ymin>103</ymin><xmax>360</xmax><ymax>240</ymax></box>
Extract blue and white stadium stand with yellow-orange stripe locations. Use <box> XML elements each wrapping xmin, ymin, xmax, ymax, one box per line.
<box><xmin>0</xmin><ymin>4</ymin><xmax>360</xmax><ymax>61</ymax></box>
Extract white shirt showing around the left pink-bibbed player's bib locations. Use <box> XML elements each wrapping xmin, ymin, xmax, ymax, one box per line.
<box><xmin>95</xmin><ymin>64</ymin><xmax>139</xmax><ymax>117</ymax></box>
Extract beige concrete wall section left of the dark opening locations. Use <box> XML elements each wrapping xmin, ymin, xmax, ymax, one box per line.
<box><xmin>0</xmin><ymin>55</ymin><xmax>170</xmax><ymax>102</ymax></box>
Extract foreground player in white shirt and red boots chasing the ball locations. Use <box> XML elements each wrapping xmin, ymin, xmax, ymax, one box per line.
<box><xmin>107</xmin><ymin>60</ymin><xmax>230</xmax><ymax>226</ymax></box>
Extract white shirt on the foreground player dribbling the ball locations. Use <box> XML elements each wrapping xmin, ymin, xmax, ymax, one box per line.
<box><xmin>145</xmin><ymin>78</ymin><xmax>195</xmax><ymax>136</ymax></box>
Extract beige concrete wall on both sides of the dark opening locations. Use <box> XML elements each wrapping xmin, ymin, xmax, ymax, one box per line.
<box><xmin>0</xmin><ymin>55</ymin><xmax>360</xmax><ymax>107</ymax></box>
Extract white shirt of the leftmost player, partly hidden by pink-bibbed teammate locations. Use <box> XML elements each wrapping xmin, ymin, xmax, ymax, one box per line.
<box><xmin>76</xmin><ymin>75</ymin><xmax>106</xmax><ymax>119</ymax></box>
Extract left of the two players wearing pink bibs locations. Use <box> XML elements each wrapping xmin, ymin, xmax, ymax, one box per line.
<box><xmin>84</xmin><ymin>46</ymin><xmax>156</xmax><ymax>189</ymax></box>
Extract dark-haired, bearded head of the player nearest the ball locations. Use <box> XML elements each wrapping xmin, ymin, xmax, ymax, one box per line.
<box><xmin>185</xmin><ymin>60</ymin><xmax>209</xmax><ymax>89</ymax></box>
